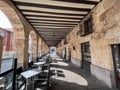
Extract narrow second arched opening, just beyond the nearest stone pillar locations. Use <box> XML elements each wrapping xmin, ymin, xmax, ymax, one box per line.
<box><xmin>28</xmin><ymin>31</ymin><xmax>37</xmax><ymax>60</ymax></box>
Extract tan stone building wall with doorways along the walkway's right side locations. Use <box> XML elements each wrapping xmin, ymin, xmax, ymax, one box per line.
<box><xmin>57</xmin><ymin>0</ymin><xmax>120</xmax><ymax>87</ymax></box>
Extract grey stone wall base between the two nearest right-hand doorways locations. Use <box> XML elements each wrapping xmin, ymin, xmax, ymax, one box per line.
<box><xmin>91</xmin><ymin>64</ymin><xmax>116</xmax><ymax>88</ymax></box>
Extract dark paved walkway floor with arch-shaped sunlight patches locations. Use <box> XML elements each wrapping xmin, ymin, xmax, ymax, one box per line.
<box><xmin>51</xmin><ymin>55</ymin><xmax>111</xmax><ymax>90</ymax></box>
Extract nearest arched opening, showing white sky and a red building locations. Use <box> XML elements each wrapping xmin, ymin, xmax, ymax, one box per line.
<box><xmin>0</xmin><ymin>11</ymin><xmax>14</xmax><ymax>72</ymax></box>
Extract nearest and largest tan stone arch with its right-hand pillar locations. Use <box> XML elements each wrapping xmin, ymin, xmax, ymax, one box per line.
<box><xmin>0</xmin><ymin>0</ymin><xmax>25</xmax><ymax>66</ymax></box>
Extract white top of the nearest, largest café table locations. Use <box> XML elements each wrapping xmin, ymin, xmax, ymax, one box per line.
<box><xmin>21</xmin><ymin>69</ymin><xmax>41</xmax><ymax>79</ymax></box>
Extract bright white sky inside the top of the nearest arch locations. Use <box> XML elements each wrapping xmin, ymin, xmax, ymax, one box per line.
<box><xmin>0</xmin><ymin>10</ymin><xmax>12</xmax><ymax>28</ymax></box>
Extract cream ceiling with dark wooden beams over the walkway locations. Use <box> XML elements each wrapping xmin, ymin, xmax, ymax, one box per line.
<box><xmin>12</xmin><ymin>0</ymin><xmax>100</xmax><ymax>46</ymax></box>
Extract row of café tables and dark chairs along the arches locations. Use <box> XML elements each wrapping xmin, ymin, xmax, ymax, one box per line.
<box><xmin>16</xmin><ymin>55</ymin><xmax>52</xmax><ymax>90</ymax></box>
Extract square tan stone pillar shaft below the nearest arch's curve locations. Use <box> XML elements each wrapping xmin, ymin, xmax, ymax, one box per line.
<box><xmin>15</xmin><ymin>37</ymin><xmax>28</xmax><ymax>70</ymax></box>
